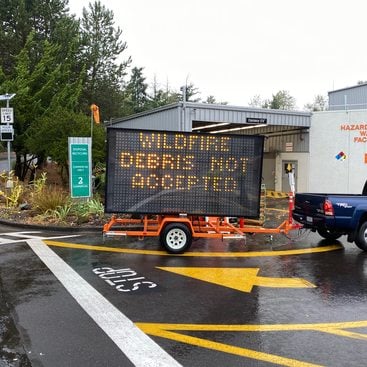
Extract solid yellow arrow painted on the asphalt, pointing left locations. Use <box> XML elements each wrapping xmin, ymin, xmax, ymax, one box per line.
<box><xmin>157</xmin><ymin>266</ymin><xmax>316</xmax><ymax>293</ymax></box>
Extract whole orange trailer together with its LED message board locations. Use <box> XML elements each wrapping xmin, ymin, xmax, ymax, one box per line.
<box><xmin>103</xmin><ymin>127</ymin><xmax>302</xmax><ymax>253</ymax></box>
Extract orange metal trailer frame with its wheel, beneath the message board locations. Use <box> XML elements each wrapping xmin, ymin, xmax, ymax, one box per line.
<box><xmin>103</xmin><ymin>193</ymin><xmax>302</xmax><ymax>253</ymax></box>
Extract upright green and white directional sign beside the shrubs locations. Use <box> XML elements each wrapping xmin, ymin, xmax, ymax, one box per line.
<box><xmin>69</xmin><ymin>138</ymin><xmax>92</xmax><ymax>198</ymax></box>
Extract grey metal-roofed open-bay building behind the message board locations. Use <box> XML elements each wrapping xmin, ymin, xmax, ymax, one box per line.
<box><xmin>112</xmin><ymin>102</ymin><xmax>311</xmax><ymax>192</ymax></box>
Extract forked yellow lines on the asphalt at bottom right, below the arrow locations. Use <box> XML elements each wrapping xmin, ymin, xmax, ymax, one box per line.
<box><xmin>136</xmin><ymin>321</ymin><xmax>367</xmax><ymax>367</ymax></box>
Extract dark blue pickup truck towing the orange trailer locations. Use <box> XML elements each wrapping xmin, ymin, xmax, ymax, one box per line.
<box><xmin>292</xmin><ymin>182</ymin><xmax>367</xmax><ymax>251</ymax></box>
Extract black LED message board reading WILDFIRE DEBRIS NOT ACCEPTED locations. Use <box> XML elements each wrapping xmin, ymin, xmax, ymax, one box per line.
<box><xmin>105</xmin><ymin>128</ymin><xmax>264</xmax><ymax>218</ymax></box>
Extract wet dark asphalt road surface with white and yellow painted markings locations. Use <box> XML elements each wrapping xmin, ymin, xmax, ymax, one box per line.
<box><xmin>0</xmin><ymin>226</ymin><xmax>367</xmax><ymax>367</ymax></box>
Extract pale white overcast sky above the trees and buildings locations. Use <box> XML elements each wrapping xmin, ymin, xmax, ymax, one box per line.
<box><xmin>69</xmin><ymin>0</ymin><xmax>367</xmax><ymax>110</ymax></box>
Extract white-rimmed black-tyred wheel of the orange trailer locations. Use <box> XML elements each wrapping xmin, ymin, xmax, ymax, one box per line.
<box><xmin>160</xmin><ymin>223</ymin><xmax>192</xmax><ymax>254</ymax></box>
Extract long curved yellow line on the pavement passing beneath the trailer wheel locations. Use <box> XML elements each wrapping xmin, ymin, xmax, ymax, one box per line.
<box><xmin>44</xmin><ymin>239</ymin><xmax>343</xmax><ymax>257</ymax></box>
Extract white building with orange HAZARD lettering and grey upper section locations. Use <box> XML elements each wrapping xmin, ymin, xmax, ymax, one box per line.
<box><xmin>309</xmin><ymin>83</ymin><xmax>367</xmax><ymax>194</ymax></box>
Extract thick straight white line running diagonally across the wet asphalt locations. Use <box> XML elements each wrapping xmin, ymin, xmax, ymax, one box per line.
<box><xmin>27</xmin><ymin>239</ymin><xmax>181</xmax><ymax>367</ymax></box>
